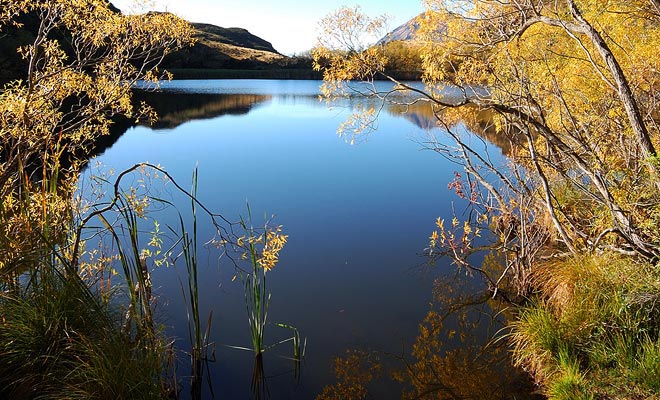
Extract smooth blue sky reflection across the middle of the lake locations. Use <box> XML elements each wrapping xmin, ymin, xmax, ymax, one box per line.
<box><xmin>80</xmin><ymin>81</ymin><xmax>508</xmax><ymax>398</ymax></box>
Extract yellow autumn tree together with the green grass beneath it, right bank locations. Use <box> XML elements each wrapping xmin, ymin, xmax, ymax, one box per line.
<box><xmin>315</xmin><ymin>0</ymin><xmax>660</xmax><ymax>398</ymax></box>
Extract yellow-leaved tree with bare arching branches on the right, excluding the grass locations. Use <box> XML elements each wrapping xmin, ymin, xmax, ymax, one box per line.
<box><xmin>315</xmin><ymin>0</ymin><xmax>660</xmax><ymax>293</ymax></box>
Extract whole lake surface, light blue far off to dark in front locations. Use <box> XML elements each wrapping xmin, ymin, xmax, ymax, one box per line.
<box><xmin>78</xmin><ymin>80</ymin><xmax>540</xmax><ymax>399</ymax></box>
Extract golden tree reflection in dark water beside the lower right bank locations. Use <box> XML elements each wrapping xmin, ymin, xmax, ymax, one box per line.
<box><xmin>317</xmin><ymin>266</ymin><xmax>542</xmax><ymax>400</ymax></box>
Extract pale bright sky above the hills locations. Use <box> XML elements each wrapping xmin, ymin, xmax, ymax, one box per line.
<box><xmin>112</xmin><ymin>0</ymin><xmax>423</xmax><ymax>55</ymax></box>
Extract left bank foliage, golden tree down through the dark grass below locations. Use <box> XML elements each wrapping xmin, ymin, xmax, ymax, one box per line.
<box><xmin>0</xmin><ymin>0</ymin><xmax>192</xmax><ymax>398</ymax></box>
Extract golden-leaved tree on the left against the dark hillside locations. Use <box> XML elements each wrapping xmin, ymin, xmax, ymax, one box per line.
<box><xmin>0</xmin><ymin>0</ymin><xmax>192</xmax><ymax>272</ymax></box>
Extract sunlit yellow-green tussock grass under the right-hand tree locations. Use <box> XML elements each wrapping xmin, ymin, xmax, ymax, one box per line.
<box><xmin>510</xmin><ymin>254</ymin><xmax>660</xmax><ymax>399</ymax></box>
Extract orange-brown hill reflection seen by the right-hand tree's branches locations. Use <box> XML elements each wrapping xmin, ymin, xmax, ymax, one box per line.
<box><xmin>387</xmin><ymin>102</ymin><xmax>517</xmax><ymax>156</ymax></box>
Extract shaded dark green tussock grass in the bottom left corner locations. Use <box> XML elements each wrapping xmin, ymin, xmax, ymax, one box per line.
<box><xmin>0</xmin><ymin>270</ymin><xmax>164</xmax><ymax>399</ymax></box>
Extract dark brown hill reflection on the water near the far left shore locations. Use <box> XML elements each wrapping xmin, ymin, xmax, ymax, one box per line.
<box><xmin>134</xmin><ymin>91</ymin><xmax>271</xmax><ymax>129</ymax></box>
